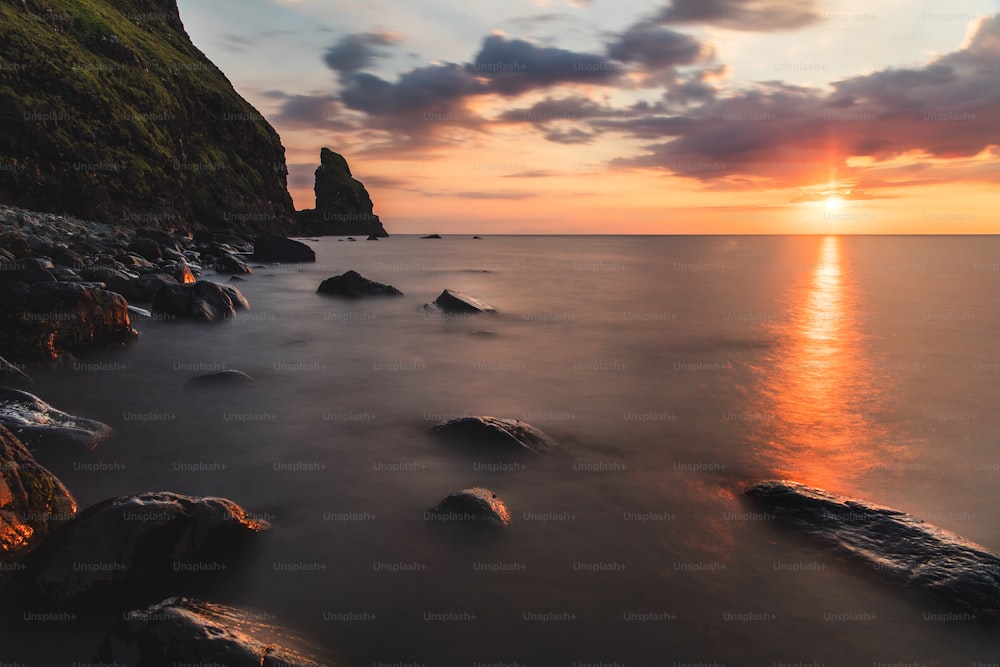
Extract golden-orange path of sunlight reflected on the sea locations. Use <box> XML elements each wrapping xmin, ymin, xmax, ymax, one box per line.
<box><xmin>755</xmin><ymin>236</ymin><xmax>893</xmax><ymax>492</ymax></box>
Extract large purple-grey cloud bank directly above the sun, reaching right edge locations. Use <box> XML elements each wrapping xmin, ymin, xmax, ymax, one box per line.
<box><xmin>605</xmin><ymin>16</ymin><xmax>1000</xmax><ymax>186</ymax></box>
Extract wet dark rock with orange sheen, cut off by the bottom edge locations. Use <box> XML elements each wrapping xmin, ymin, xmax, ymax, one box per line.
<box><xmin>94</xmin><ymin>597</ymin><xmax>334</xmax><ymax>667</ymax></box>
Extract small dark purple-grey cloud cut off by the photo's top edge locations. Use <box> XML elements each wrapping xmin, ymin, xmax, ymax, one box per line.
<box><xmin>656</xmin><ymin>0</ymin><xmax>822</xmax><ymax>32</ymax></box>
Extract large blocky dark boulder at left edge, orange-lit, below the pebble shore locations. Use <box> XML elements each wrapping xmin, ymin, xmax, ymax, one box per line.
<box><xmin>0</xmin><ymin>283</ymin><xmax>138</xmax><ymax>360</ymax></box>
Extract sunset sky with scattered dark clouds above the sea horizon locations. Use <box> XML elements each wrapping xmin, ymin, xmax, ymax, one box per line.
<box><xmin>178</xmin><ymin>0</ymin><xmax>1000</xmax><ymax>234</ymax></box>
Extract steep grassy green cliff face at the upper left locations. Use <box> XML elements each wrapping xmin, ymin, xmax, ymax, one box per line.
<box><xmin>0</xmin><ymin>0</ymin><xmax>294</xmax><ymax>232</ymax></box>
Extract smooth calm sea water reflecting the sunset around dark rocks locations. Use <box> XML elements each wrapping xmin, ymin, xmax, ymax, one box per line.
<box><xmin>8</xmin><ymin>236</ymin><xmax>1000</xmax><ymax>667</ymax></box>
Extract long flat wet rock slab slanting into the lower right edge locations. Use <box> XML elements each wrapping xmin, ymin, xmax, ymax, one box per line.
<box><xmin>746</xmin><ymin>480</ymin><xmax>1000</xmax><ymax>614</ymax></box>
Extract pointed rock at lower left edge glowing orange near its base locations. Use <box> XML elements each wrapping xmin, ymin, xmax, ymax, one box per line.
<box><xmin>0</xmin><ymin>425</ymin><xmax>76</xmax><ymax>563</ymax></box>
